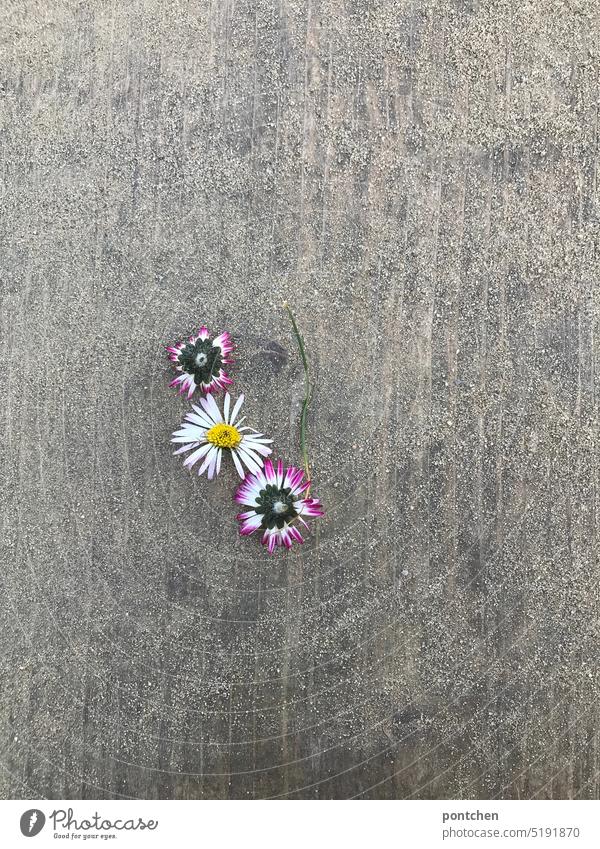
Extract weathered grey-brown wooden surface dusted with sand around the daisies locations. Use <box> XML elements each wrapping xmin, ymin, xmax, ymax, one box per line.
<box><xmin>0</xmin><ymin>0</ymin><xmax>600</xmax><ymax>798</ymax></box>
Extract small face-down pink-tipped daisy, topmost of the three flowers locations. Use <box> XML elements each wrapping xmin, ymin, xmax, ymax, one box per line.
<box><xmin>167</xmin><ymin>327</ymin><xmax>233</xmax><ymax>398</ymax></box>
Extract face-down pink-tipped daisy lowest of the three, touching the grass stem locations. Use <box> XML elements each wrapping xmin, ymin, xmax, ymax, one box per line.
<box><xmin>235</xmin><ymin>460</ymin><xmax>323</xmax><ymax>554</ymax></box>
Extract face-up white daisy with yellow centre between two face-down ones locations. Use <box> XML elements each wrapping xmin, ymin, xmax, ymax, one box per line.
<box><xmin>171</xmin><ymin>392</ymin><xmax>273</xmax><ymax>480</ymax></box>
